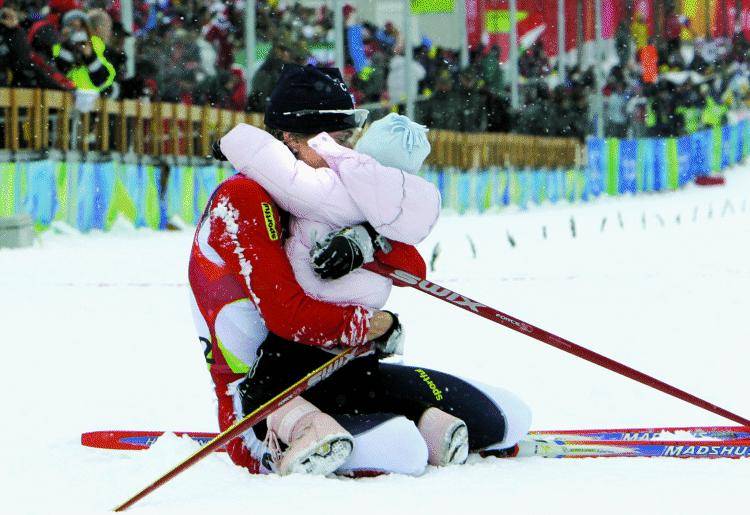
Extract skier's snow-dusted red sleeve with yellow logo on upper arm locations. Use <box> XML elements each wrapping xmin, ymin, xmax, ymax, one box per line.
<box><xmin>209</xmin><ymin>176</ymin><xmax>370</xmax><ymax>347</ymax></box>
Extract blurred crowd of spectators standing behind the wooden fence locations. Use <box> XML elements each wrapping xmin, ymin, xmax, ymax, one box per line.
<box><xmin>0</xmin><ymin>0</ymin><xmax>750</xmax><ymax>139</ymax></box>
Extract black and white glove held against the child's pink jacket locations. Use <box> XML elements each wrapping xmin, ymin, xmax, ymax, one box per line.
<box><xmin>310</xmin><ymin>223</ymin><xmax>391</xmax><ymax>279</ymax></box>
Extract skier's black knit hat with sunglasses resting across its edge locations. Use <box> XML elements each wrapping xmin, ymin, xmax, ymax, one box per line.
<box><xmin>265</xmin><ymin>64</ymin><xmax>367</xmax><ymax>134</ymax></box>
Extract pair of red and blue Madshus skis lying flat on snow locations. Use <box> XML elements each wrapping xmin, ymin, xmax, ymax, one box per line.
<box><xmin>81</xmin><ymin>426</ymin><xmax>750</xmax><ymax>458</ymax></box>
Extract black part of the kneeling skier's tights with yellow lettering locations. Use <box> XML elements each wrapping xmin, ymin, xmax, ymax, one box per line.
<box><xmin>239</xmin><ymin>335</ymin><xmax>506</xmax><ymax>450</ymax></box>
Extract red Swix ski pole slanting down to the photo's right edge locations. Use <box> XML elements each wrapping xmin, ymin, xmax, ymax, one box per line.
<box><xmin>364</xmin><ymin>261</ymin><xmax>750</xmax><ymax>426</ymax></box>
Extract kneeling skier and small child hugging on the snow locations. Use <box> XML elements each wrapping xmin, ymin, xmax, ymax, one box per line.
<box><xmin>189</xmin><ymin>65</ymin><xmax>531</xmax><ymax>475</ymax></box>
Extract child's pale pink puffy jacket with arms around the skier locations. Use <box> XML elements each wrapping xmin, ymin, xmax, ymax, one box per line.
<box><xmin>221</xmin><ymin>124</ymin><xmax>440</xmax><ymax>308</ymax></box>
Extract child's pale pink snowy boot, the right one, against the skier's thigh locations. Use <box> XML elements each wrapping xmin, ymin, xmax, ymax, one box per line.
<box><xmin>417</xmin><ymin>408</ymin><xmax>469</xmax><ymax>467</ymax></box>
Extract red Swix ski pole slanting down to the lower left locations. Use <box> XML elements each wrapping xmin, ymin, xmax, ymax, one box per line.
<box><xmin>114</xmin><ymin>345</ymin><xmax>371</xmax><ymax>511</ymax></box>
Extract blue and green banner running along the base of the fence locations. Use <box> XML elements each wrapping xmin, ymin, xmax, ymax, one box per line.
<box><xmin>0</xmin><ymin>121</ymin><xmax>750</xmax><ymax>232</ymax></box>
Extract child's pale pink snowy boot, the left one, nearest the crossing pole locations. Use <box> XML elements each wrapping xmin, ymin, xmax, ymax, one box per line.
<box><xmin>267</xmin><ymin>397</ymin><xmax>354</xmax><ymax>476</ymax></box>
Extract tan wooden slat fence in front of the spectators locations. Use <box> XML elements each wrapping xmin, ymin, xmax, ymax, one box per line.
<box><xmin>0</xmin><ymin>88</ymin><xmax>581</xmax><ymax>170</ymax></box>
